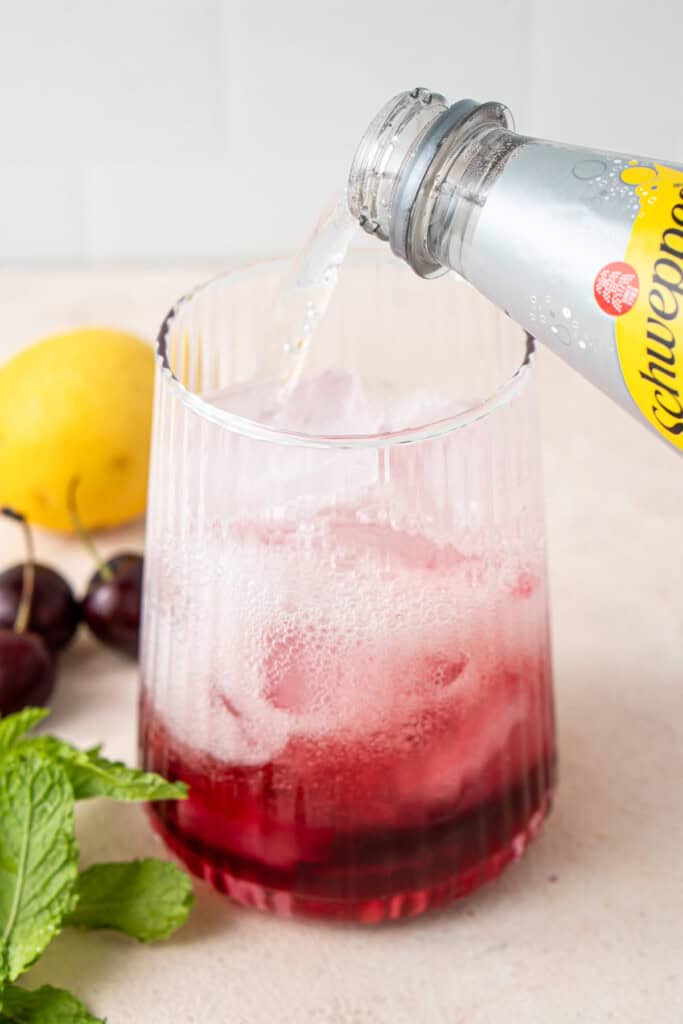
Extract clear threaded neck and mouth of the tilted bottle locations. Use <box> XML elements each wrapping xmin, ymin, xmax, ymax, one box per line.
<box><xmin>348</xmin><ymin>89</ymin><xmax>524</xmax><ymax>278</ymax></box>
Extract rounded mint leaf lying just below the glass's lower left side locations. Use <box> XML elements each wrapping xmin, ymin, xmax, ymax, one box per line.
<box><xmin>65</xmin><ymin>857</ymin><xmax>195</xmax><ymax>942</ymax></box>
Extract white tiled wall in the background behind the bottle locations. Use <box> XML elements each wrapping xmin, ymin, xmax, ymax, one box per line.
<box><xmin>0</xmin><ymin>0</ymin><xmax>683</xmax><ymax>267</ymax></box>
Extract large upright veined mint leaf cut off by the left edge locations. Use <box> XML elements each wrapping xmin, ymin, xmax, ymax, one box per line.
<box><xmin>0</xmin><ymin>748</ymin><xmax>78</xmax><ymax>978</ymax></box>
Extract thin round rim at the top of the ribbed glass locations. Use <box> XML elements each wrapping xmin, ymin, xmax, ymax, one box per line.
<box><xmin>155</xmin><ymin>251</ymin><xmax>537</xmax><ymax>449</ymax></box>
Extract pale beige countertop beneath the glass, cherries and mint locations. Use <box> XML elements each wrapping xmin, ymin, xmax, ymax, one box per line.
<box><xmin>0</xmin><ymin>268</ymin><xmax>683</xmax><ymax>1024</ymax></box>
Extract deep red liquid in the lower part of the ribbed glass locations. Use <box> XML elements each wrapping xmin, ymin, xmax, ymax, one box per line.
<box><xmin>141</xmin><ymin>538</ymin><xmax>555</xmax><ymax>922</ymax></box>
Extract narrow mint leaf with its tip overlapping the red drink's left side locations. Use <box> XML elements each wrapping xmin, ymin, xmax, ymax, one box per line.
<box><xmin>14</xmin><ymin>736</ymin><xmax>187</xmax><ymax>801</ymax></box>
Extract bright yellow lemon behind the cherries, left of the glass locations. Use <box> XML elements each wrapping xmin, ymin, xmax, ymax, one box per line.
<box><xmin>0</xmin><ymin>328</ymin><xmax>155</xmax><ymax>530</ymax></box>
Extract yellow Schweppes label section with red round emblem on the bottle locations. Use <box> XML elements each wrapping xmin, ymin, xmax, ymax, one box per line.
<box><xmin>594</xmin><ymin>161</ymin><xmax>683</xmax><ymax>451</ymax></box>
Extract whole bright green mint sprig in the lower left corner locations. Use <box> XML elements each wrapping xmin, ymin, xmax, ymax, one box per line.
<box><xmin>0</xmin><ymin>709</ymin><xmax>194</xmax><ymax>1024</ymax></box>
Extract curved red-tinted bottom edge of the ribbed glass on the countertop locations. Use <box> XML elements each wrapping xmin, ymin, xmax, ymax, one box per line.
<box><xmin>150</xmin><ymin>791</ymin><xmax>553</xmax><ymax>925</ymax></box>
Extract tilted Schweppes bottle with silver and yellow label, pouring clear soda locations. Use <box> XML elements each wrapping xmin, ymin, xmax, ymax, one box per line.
<box><xmin>348</xmin><ymin>89</ymin><xmax>683</xmax><ymax>452</ymax></box>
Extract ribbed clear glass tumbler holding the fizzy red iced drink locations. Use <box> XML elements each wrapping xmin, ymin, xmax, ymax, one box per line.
<box><xmin>140</xmin><ymin>254</ymin><xmax>555</xmax><ymax>922</ymax></box>
